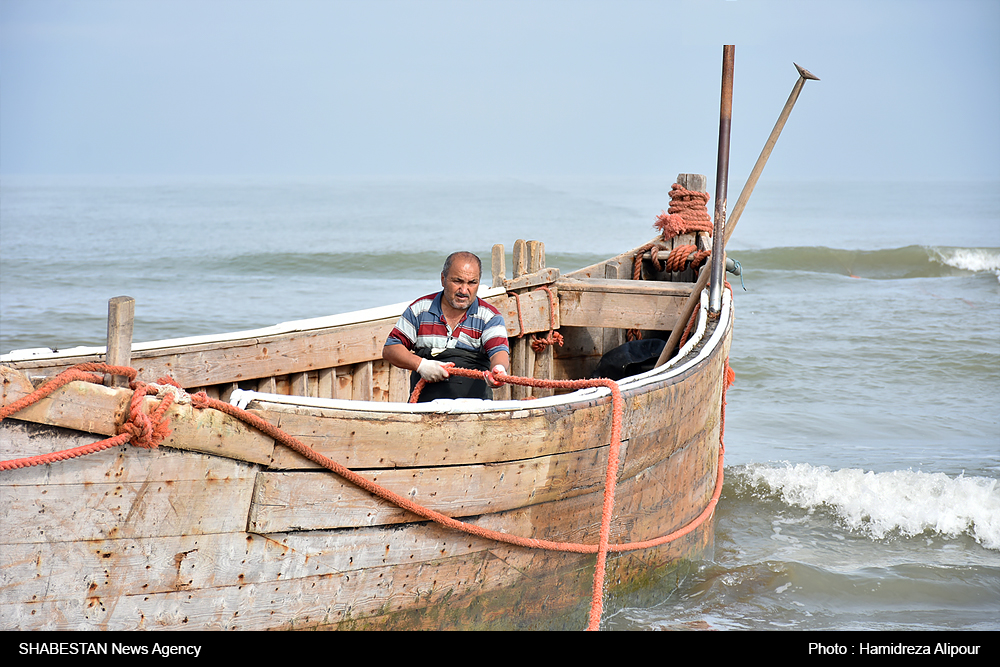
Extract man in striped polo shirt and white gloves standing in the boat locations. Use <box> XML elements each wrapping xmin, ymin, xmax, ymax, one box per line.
<box><xmin>382</xmin><ymin>252</ymin><xmax>510</xmax><ymax>402</ymax></box>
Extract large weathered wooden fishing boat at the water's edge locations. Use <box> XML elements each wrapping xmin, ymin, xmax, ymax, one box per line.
<box><xmin>0</xmin><ymin>177</ymin><xmax>733</xmax><ymax>630</ymax></box>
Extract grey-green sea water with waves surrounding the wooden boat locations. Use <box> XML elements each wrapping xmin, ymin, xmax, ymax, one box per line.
<box><xmin>0</xmin><ymin>175</ymin><xmax>1000</xmax><ymax>630</ymax></box>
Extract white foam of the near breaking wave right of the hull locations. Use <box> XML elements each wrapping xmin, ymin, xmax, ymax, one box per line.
<box><xmin>744</xmin><ymin>463</ymin><xmax>1000</xmax><ymax>550</ymax></box>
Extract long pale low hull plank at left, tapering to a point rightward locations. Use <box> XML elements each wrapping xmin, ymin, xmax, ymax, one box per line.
<box><xmin>0</xmin><ymin>529</ymin><xmax>496</xmax><ymax>612</ymax></box>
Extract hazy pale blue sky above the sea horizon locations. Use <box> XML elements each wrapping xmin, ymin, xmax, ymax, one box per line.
<box><xmin>0</xmin><ymin>0</ymin><xmax>1000</xmax><ymax>182</ymax></box>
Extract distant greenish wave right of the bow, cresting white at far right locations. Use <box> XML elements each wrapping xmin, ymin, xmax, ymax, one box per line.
<box><xmin>729</xmin><ymin>245</ymin><xmax>1000</xmax><ymax>280</ymax></box>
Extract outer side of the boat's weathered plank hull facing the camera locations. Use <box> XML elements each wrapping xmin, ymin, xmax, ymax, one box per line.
<box><xmin>0</xmin><ymin>290</ymin><xmax>732</xmax><ymax>630</ymax></box>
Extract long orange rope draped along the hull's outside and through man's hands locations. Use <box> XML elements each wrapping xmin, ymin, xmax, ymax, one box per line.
<box><xmin>0</xmin><ymin>360</ymin><xmax>733</xmax><ymax>630</ymax></box>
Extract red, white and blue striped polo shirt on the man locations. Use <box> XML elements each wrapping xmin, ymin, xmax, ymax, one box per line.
<box><xmin>385</xmin><ymin>292</ymin><xmax>510</xmax><ymax>357</ymax></box>
